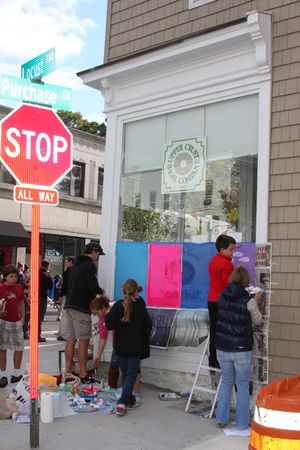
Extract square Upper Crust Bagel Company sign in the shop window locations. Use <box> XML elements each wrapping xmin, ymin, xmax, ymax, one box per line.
<box><xmin>161</xmin><ymin>137</ymin><xmax>206</xmax><ymax>194</ymax></box>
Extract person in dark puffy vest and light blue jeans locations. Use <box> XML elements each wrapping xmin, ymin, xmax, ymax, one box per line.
<box><xmin>216</xmin><ymin>267</ymin><xmax>262</xmax><ymax>430</ymax></box>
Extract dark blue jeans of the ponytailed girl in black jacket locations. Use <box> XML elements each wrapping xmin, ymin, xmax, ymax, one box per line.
<box><xmin>117</xmin><ymin>356</ymin><xmax>141</xmax><ymax>406</ymax></box>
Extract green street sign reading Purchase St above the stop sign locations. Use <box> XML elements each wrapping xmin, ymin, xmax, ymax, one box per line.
<box><xmin>0</xmin><ymin>74</ymin><xmax>72</xmax><ymax>111</ymax></box>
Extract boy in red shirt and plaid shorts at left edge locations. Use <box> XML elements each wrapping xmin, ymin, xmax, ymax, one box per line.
<box><xmin>0</xmin><ymin>264</ymin><xmax>25</xmax><ymax>388</ymax></box>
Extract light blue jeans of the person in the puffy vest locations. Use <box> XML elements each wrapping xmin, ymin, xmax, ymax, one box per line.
<box><xmin>216</xmin><ymin>350</ymin><xmax>252</xmax><ymax>430</ymax></box>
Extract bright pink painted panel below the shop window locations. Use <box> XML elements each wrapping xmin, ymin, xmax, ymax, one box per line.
<box><xmin>147</xmin><ymin>244</ymin><xmax>182</xmax><ymax>308</ymax></box>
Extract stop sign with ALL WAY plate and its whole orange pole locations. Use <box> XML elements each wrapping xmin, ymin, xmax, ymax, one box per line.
<box><xmin>0</xmin><ymin>105</ymin><xmax>73</xmax><ymax>448</ymax></box>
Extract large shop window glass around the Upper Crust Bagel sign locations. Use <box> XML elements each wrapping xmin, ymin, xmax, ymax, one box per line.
<box><xmin>119</xmin><ymin>96</ymin><xmax>258</xmax><ymax>242</ymax></box>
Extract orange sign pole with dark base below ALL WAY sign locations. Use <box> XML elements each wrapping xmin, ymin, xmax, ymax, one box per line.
<box><xmin>29</xmin><ymin>205</ymin><xmax>40</xmax><ymax>448</ymax></box>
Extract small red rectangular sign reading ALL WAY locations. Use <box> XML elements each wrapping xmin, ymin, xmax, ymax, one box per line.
<box><xmin>14</xmin><ymin>185</ymin><xmax>58</xmax><ymax>206</ymax></box>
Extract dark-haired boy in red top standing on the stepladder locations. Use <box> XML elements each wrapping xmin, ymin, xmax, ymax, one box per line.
<box><xmin>208</xmin><ymin>234</ymin><xmax>236</xmax><ymax>368</ymax></box>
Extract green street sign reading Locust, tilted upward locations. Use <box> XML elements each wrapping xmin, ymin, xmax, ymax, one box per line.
<box><xmin>21</xmin><ymin>48</ymin><xmax>55</xmax><ymax>80</ymax></box>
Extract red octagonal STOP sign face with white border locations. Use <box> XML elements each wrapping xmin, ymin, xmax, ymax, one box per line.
<box><xmin>0</xmin><ymin>104</ymin><xmax>72</xmax><ymax>187</ymax></box>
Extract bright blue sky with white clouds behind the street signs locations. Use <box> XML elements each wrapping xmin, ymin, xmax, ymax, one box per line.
<box><xmin>0</xmin><ymin>0</ymin><xmax>107</xmax><ymax>123</ymax></box>
